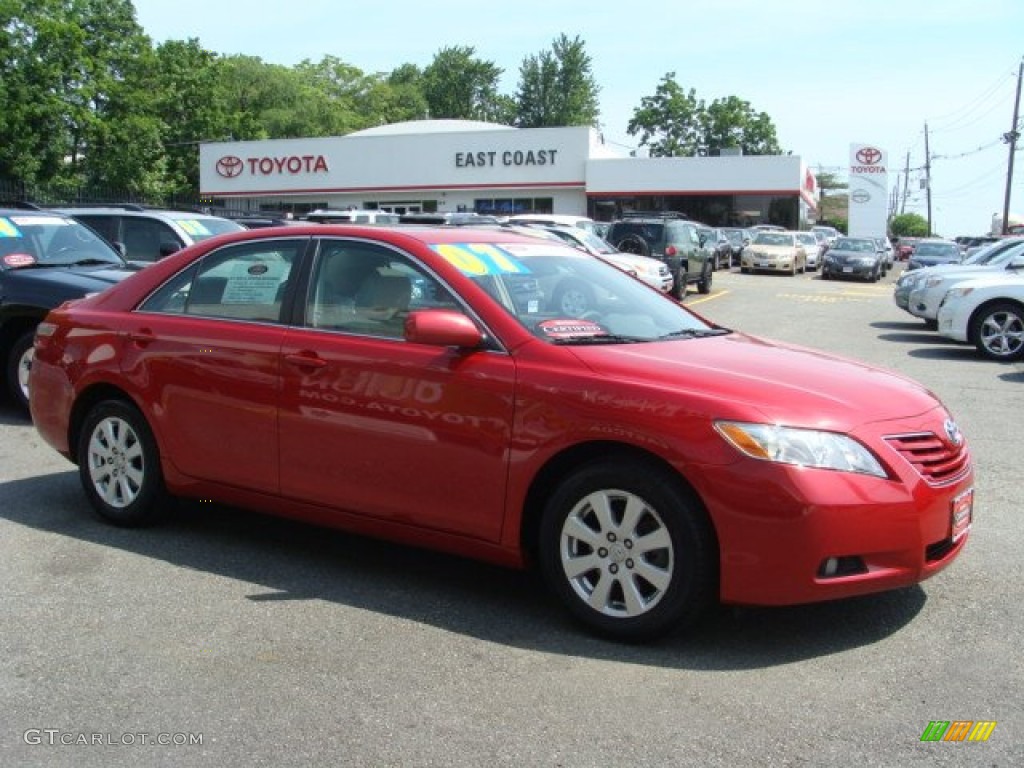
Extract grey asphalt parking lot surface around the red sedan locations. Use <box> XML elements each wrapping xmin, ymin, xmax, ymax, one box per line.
<box><xmin>0</xmin><ymin>270</ymin><xmax>1024</xmax><ymax>768</ymax></box>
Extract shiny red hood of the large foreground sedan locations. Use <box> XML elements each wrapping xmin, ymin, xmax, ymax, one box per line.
<box><xmin>567</xmin><ymin>333</ymin><xmax>939</xmax><ymax>431</ymax></box>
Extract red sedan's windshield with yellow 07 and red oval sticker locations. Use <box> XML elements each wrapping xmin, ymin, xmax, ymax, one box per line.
<box><xmin>432</xmin><ymin>241</ymin><xmax>726</xmax><ymax>344</ymax></box>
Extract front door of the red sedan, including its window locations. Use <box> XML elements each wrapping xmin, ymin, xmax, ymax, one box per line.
<box><xmin>281</xmin><ymin>240</ymin><xmax>515</xmax><ymax>541</ymax></box>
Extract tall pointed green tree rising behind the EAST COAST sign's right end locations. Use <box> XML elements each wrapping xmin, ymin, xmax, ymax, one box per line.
<box><xmin>516</xmin><ymin>34</ymin><xmax>600</xmax><ymax>128</ymax></box>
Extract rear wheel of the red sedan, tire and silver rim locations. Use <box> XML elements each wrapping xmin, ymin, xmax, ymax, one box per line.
<box><xmin>77</xmin><ymin>400</ymin><xmax>170</xmax><ymax>527</ymax></box>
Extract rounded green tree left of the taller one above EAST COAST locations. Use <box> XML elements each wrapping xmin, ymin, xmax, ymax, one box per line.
<box><xmin>423</xmin><ymin>46</ymin><xmax>507</xmax><ymax>122</ymax></box>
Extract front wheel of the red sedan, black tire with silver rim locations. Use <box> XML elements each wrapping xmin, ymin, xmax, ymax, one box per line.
<box><xmin>539</xmin><ymin>461</ymin><xmax>718</xmax><ymax>641</ymax></box>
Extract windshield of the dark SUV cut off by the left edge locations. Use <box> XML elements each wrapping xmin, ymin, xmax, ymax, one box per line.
<box><xmin>0</xmin><ymin>215</ymin><xmax>124</xmax><ymax>267</ymax></box>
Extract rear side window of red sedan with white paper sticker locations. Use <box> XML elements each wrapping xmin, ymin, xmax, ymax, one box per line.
<box><xmin>140</xmin><ymin>240</ymin><xmax>305</xmax><ymax>323</ymax></box>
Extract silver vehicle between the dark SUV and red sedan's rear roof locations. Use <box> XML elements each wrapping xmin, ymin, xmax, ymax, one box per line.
<box><xmin>55</xmin><ymin>203</ymin><xmax>245</xmax><ymax>266</ymax></box>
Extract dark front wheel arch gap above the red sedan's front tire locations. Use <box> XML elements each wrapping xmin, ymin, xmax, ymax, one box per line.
<box><xmin>519</xmin><ymin>440</ymin><xmax>720</xmax><ymax>563</ymax></box>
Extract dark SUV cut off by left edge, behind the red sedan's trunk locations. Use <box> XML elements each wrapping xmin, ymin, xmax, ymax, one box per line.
<box><xmin>0</xmin><ymin>207</ymin><xmax>135</xmax><ymax>410</ymax></box>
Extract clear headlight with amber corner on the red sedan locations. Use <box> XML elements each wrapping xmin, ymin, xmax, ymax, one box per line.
<box><xmin>715</xmin><ymin>421</ymin><xmax>887</xmax><ymax>477</ymax></box>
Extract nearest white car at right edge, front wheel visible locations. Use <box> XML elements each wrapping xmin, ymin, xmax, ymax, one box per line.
<box><xmin>938</xmin><ymin>273</ymin><xmax>1024</xmax><ymax>361</ymax></box>
